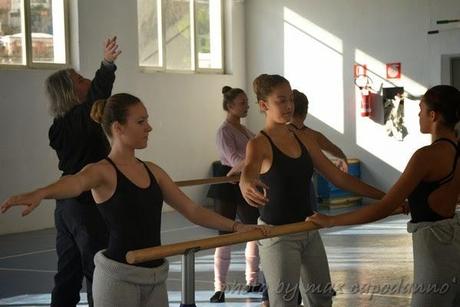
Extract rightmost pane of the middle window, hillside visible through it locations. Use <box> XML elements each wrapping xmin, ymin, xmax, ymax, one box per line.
<box><xmin>195</xmin><ymin>0</ymin><xmax>222</xmax><ymax>69</ymax></box>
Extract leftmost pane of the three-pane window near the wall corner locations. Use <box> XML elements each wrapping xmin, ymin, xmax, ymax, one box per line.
<box><xmin>137</xmin><ymin>0</ymin><xmax>163</xmax><ymax>67</ymax></box>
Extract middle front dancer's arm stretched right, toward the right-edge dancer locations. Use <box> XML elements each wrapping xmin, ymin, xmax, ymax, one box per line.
<box><xmin>301</xmin><ymin>135</ymin><xmax>385</xmax><ymax>199</ymax></box>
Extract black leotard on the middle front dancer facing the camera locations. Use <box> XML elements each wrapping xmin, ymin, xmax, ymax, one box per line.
<box><xmin>260</xmin><ymin>131</ymin><xmax>313</xmax><ymax>225</ymax></box>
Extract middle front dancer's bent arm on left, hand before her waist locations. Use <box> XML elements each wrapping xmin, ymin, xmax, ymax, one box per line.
<box><xmin>240</xmin><ymin>137</ymin><xmax>268</xmax><ymax>207</ymax></box>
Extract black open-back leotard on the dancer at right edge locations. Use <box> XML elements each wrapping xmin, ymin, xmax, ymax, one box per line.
<box><xmin>408</xmin><ymin>138</ymin><xmax>460</xmax><ymax>223</ymax></box>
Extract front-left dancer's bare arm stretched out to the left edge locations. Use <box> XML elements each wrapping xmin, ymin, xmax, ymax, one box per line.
<box><xmin>0</xmin><ymin>164</ymin><xmax>104</xmax><ymax>216</ymax></box>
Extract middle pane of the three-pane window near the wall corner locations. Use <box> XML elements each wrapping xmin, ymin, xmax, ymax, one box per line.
<box><xmin>163</xmin><ymin>0</ymin><xmax>193</xmax><ymax>70</ymax></box>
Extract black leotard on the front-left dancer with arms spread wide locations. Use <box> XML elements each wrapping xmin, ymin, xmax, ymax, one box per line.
<box><xmin>97</xmin><ymin>157</ymin><xmax>164</xmax><ymax>267</ymax></box>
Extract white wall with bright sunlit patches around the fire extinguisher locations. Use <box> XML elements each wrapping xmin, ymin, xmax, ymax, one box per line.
<box><xmin>246</xmin><ymin>0</ymin><xmax>460</xmax><ymax>190</ymax></box>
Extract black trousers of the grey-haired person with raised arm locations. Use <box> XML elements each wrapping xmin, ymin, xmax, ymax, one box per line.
<box><xmin>51</xmin><ymin>195</ymin><xmax>108</xmax><ymax>307</ymax></box>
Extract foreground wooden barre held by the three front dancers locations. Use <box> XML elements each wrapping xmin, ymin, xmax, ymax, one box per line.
<box><xmin>126</xmin><ymin>222</ymin><xmax>319</xmax><ymax>264</ymax></box>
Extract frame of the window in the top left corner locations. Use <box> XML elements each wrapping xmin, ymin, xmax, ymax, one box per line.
<box><xmin>0</xmin><ymin>0</ymin><xmax>70</xmax><ymax>70</ymax></box>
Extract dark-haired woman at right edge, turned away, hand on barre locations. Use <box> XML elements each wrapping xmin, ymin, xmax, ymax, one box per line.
<box><xmin>310</xmin><ymin>85</ymin><xmax>460</xmax><ymax>307</ymax></box>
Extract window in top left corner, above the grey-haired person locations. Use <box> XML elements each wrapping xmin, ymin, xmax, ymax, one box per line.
<box><xmin>0</xmin><ymin>0</ymin><xmax>68</xmax><ymax>67</ymax></box>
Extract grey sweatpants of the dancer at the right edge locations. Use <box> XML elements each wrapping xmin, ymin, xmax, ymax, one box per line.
<box><xmin>407</xmin><ymin>215</ymin><xmax>460</xmax><ymax>307</ymax></box>
